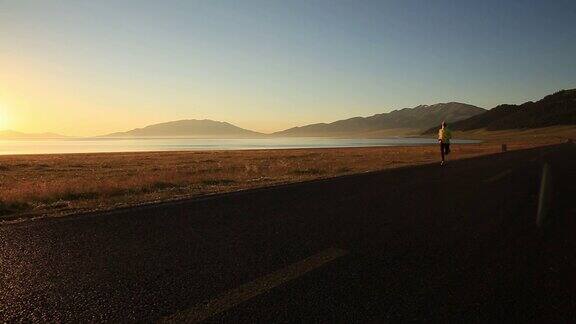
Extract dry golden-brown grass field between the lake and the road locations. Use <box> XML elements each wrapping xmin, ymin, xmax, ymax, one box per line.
<box><xmin>0</xmin><ymin>138</ymin><xmax>568</xmax><ymax>220</ymax></box>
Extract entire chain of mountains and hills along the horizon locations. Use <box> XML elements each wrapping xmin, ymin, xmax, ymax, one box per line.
<box><xmin>0</xmin><ymin>89</ymin><xmax>576</xmax><ymax>139</ymax></box>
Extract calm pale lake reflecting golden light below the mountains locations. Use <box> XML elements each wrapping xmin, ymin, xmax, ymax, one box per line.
<box><xmin>0</xmin><ymin>138</ymin><xmax>477</xmax><ymax>155</ymax></box>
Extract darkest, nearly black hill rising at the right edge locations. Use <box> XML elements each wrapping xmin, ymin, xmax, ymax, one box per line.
<box><xmin>425</xmin><ymin>89</ymin><xmax>576</xmax><ymax>134</ymax></box>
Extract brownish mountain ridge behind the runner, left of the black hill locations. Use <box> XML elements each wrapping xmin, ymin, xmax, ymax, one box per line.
<box><xmin>274</xmin><ymin>102</ymin><xmax>486</xmax><ymax>136</ymax></box>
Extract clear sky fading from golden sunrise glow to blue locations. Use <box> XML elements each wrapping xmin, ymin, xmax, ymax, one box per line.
<box><xmin>0</xmin><ymin>0</ymin><xmax>576</xmax><ymax>135</ymax></box>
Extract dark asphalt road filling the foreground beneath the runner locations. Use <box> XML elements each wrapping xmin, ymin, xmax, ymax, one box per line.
<box><xmin>0</xmin><ymin>144</ymin><xmax>576</xmax><ymax>323</ymax></box>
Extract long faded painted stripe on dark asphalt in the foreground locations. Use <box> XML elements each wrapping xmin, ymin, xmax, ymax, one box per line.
<box><xmin>160</xmin><ymin>248</ymin><xmax>348</xmax><ymax>323</ymax></box>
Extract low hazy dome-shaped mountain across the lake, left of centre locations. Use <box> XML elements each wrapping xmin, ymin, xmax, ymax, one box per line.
<box><xmin>106</xmin><ymin>119</ymin><xmax>262</xmax><ymax>138</ymax></box>
